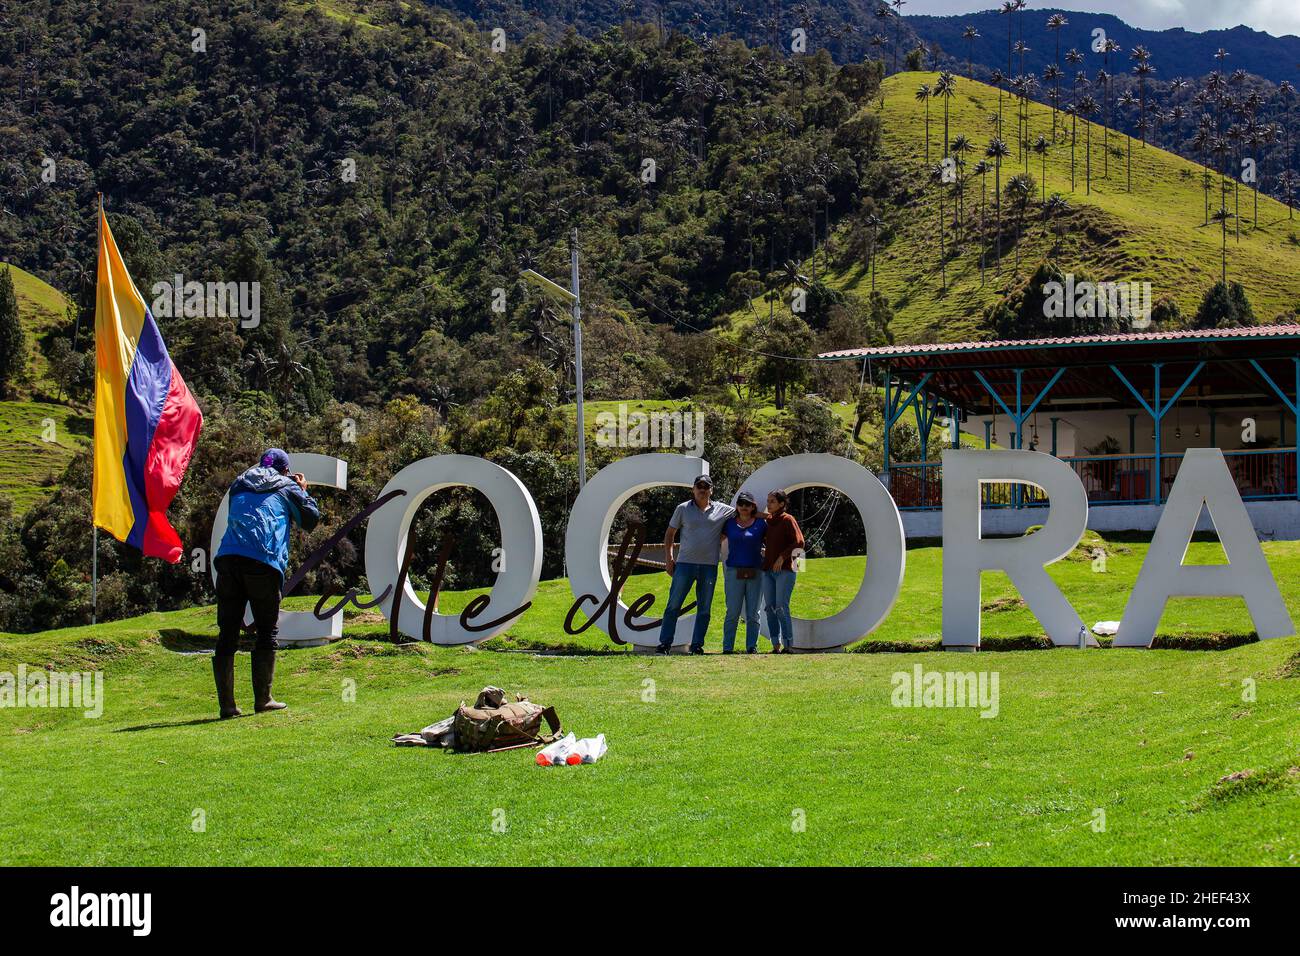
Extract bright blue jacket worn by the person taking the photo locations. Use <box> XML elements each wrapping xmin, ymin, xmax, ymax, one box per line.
<box><xmin>216</xmin><ymin>466</ymin><xmax>321</xmax><ymax>579</ymax></box>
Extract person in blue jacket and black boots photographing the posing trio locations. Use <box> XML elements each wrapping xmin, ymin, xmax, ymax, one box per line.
<box><xmin>212</xmin><ymin>449</ymin><xmax>321</xmax><ymax>719</ymax></box>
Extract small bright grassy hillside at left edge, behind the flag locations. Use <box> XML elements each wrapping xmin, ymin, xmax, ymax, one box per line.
<box><xmin>0</xmin><ymin>264</ymin><xmax>92</xmax><ymax>512</ymax></box>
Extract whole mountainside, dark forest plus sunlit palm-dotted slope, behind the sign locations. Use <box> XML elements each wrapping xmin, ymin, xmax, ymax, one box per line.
<box><xmin>0</xmin><ymin>0</ymin><xmax>1300</xmax><ymax>631</ymax></box>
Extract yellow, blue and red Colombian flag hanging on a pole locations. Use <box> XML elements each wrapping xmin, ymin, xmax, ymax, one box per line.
<box><xmin>94</xmin><ymin>203</ymin><xmax>203</xmax><ymax>564</ymax></box>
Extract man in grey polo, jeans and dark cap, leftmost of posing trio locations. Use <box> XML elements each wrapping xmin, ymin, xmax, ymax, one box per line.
<box><xmin>658</xmin><ymin>475</ymin><xmax>736</xmax><ymax>654</ymax></box>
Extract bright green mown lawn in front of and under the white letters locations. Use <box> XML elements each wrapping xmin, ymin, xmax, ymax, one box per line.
<box><xmin>0</xmin><ymin>538</ymin><xmax>1300</xmax><ymax>866</ymax></box>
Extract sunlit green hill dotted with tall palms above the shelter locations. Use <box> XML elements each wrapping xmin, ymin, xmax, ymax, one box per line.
<box><xmin>733</xmin><ymin>73</ymin><xmax>1300</xmax><ymax>342</ymax></box>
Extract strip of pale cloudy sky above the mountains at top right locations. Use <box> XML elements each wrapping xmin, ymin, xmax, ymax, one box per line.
<box><xmin>904</xmin><ymin>0</ymin><xmax>1300</xmax><ymax>36</ymax></box>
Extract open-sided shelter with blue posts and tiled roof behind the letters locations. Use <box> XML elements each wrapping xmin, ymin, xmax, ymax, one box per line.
<box><xmin>820</xmin><ymin>325</ymin><xmax>1300</xmax><ymax>537</ymax></box>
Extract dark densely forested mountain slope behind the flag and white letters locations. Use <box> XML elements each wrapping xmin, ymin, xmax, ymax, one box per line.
<box><xmin>0</xmin><ymin>0</ymin><xmax>893</xmax><ymax>630</ymax></box>
